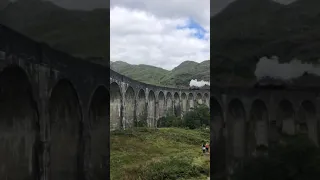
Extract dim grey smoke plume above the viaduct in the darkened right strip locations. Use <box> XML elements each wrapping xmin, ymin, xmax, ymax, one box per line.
<box><xmin>255</xmin><ymin>56</ymin><xmax>320</xmax><ymax>80</ymax></box>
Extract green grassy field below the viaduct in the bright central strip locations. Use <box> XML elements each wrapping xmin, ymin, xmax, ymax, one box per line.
<box><xmin>110</xmin><ymin>128</ymin><xmax>210</xmax><ymax>180</ymax></box>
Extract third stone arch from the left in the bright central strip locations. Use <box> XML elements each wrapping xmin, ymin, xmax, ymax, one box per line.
<box><xmin>137</xmin><ymin>89</ymin><xmax>147</xmax><ymax>122</ymax></box>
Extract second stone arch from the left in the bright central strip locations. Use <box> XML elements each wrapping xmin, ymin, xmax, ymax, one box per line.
<box><xmin>124</xmin><ymin>86</ymin><xmax>135</xmax><ymax>128</ymax></box>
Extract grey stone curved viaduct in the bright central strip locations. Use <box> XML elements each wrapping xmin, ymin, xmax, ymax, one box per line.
<box><xmin>110</xmin><ymin>70</ymin><xmax>210</xmax><ymax>130</ymax></box>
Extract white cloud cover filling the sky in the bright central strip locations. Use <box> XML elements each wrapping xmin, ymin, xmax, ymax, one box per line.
<box><xmin>110</xmin><ymin>0</ymin><xmax>210</xmax><ymax>69</ymax></box>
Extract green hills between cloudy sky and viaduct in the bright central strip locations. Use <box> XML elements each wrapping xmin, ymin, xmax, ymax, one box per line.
<box><xmin>110</xmin><ymin>60</ymin><xmax>210</xmax><ymax>87</ymax></box>
